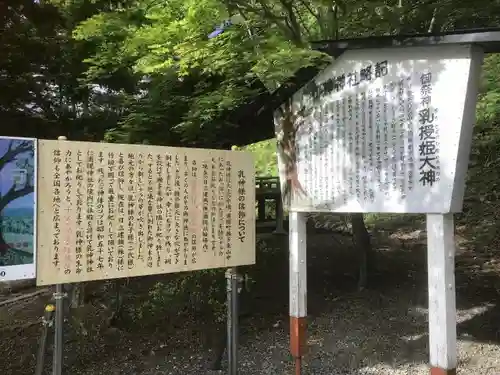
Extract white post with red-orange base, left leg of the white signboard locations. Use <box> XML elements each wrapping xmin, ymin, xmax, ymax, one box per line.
<box><xmin>289</xmin><ymin>211</ymin><xmax>307</xmax><ymax>375</ymax></box>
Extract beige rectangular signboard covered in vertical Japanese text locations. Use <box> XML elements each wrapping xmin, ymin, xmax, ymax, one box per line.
<box><xmin>37</xmin><ymin>140</ymin><xmax>255</xmax><ymax>285</ymax></box>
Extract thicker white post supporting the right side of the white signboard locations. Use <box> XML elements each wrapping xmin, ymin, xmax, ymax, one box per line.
<box><xmin>427</xmin><ymin>213</ymin><xmax>457</xmax><ymax>375</ymax></box>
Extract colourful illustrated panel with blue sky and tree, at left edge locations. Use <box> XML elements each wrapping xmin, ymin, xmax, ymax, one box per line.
<box><xmin>0</xmin><ymin>137</ymin><xmax>36</xmax><ymax>281</ymax></box>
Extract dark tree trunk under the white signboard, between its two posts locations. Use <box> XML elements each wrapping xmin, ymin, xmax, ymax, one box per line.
<box><xmin>351</xmin><ymin>214</ymin><xmax>372</xmax><ymax>290</ymax></box>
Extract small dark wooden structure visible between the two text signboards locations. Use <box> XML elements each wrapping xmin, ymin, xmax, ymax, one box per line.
<box><xmin>255</xmin><ymin>177</ymin><xmax>286</xmax><ymax>234</ymax></box>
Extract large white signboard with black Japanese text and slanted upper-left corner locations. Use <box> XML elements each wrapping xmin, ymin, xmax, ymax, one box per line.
<box><xmin>275</xmin><ymin>45</ymin><xmax>482</xmax><ymax>213</ymax></box>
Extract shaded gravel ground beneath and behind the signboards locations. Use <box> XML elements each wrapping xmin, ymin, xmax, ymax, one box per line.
<box><xmin>0</xmin><ymin>231</ymin><xmax>500</xmax><ymax>375</ymax></box>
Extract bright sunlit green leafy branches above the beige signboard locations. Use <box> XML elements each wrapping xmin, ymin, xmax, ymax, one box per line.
<box><xmin>67</xmin><ymin>0</ymin><xmax>332</xmax><ymax>144</ymax></box>
